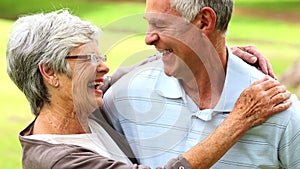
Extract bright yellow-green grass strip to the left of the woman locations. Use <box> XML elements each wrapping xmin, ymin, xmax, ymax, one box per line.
<box><xmin>0</xmin><ymin>17</ymin><xmax>31</xmax><ymax>169</ymax></box>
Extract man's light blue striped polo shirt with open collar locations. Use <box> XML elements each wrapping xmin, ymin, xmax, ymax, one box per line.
<box><xmin>104</xmin><ymin>48</ymin><xmax>300</xmax><ymax>169</ymax></box>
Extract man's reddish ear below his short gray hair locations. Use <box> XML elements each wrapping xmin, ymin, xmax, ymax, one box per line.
<box><xmin>192</xmin><ymin>7</ymin><xmax>217</xmax><ymax>35</ymax></box>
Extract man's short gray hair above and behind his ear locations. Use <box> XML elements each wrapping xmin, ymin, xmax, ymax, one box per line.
<box><xmin>171</xmin><ymin>0</ymin><xmax>234</xmax><ymax>33</ymax></box>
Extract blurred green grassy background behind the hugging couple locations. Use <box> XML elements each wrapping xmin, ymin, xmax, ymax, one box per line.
<box><xmin>0</xmin><ymin>0</ymin><xmax>300</xmax><ymax>169</ymax></box>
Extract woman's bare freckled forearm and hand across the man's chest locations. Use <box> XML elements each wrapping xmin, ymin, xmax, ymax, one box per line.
<box><xmin>183</xmin><ymin>77</ymin><xmax>291</xmax><ymax>169</ymax></box>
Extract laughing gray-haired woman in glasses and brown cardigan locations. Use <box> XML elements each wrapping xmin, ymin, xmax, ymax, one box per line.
<box><xmin>7</xmin><ymin>10</ymin><xmax>291</xmax><ymax>169</ymax></box>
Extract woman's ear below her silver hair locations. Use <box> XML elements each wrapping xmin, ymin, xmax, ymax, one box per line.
<box><xmin>39</xmin><ymin>64</ymin><xmax>59</xmax><ymax>87</ymax></box>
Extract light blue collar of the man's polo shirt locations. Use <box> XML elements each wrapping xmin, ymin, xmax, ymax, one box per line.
<box><xmin>155</xmin><ymin>48</ymin><xmax>263</xmax><ymax>112</ymax></box>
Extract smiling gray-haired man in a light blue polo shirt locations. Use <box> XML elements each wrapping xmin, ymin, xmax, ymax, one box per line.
<box><xmin>104</xmin><ymin>0</ymin><xmax>300</xmax><ymax>169</ymax></box>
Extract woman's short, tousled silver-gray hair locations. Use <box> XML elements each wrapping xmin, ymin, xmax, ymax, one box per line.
<box><xmin>6</xmin><ymin>10</ymin><xmax>101</xmax><ymax>115</ymax></box>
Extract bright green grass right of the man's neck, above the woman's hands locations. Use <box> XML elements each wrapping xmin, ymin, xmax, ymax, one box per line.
<box><xmin>228</xmin><ymin>16</ymin><xmax>300</xmax><ymax>76</ymax></box>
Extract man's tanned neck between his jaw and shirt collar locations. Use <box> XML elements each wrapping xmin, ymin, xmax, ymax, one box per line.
<box><xmin>182</xmin><ymin>35</ymin><xmax>227</xmax><ymax>109</ymax></box>
